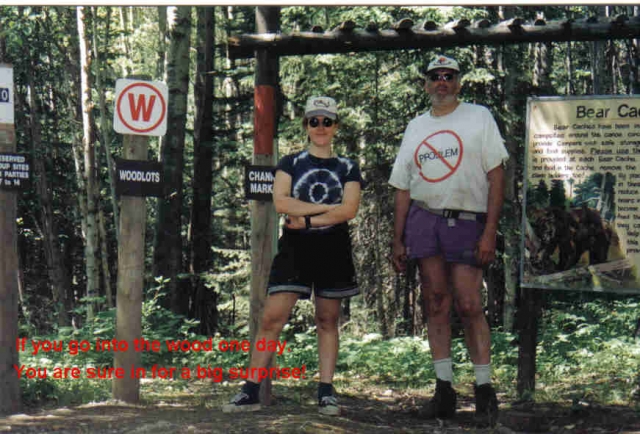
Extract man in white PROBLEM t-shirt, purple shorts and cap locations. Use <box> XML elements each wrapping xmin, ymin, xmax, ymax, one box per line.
<box><xmin>389</xmin><ymin>55</ymin><xmax>508</xmax><ymax>425</ymax></box>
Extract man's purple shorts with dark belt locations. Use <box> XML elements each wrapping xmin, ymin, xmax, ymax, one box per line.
<box><xmin>404</xmin><ymin>204</ymin><xmax>485</xmax><ymax>267</ymax></box>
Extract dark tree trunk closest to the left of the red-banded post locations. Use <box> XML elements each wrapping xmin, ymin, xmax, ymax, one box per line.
<box><xmin>189</xmin><ymin>7</ymin><xmax>218</xmax><ymax>335</ymax></box>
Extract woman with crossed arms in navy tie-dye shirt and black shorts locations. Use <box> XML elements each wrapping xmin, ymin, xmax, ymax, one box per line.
<box><xmin>223</xmin><ymin>97</ymin><xmax>362</xmax><ymax>415</ymax></box>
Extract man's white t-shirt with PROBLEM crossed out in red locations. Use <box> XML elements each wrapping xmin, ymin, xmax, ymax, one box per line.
<box><xmin>389</xmin><ymin>103</ymin><xmax>509</xmax><ymax>212</ymax></box>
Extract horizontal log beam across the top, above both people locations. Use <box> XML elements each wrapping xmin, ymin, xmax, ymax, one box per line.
<box><xmin>228</xmin><ymin>16</ymin><xmax>640</xmax><ymax>59</ymax></box>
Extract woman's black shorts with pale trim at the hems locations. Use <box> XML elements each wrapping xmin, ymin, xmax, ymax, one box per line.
<box><xmin>267</xmin><ymin>225</ymin><xmax>360</xmax><ymax>298</ymax></box>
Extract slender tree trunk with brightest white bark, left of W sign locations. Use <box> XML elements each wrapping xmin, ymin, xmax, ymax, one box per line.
<box><xmin>76</xmin><ymin>6</ymin><xmax>100</xmax><ymax>321</ymax></box>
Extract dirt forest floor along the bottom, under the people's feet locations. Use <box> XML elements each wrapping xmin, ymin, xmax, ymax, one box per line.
<box><xmin>0</xmin><ymin>380</ymin><xmax>640</xmax><ymax>434</ymax></box>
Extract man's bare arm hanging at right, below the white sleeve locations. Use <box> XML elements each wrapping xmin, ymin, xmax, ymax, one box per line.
<box><xmin>476</xmin><ymin>164</ymin><xmax>504</xmax><ymax>265</ymax></box>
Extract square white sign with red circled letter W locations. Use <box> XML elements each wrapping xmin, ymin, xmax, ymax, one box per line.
<box><xmin>113</xmin><ymin>78</ymin><xmax>169</xmax><ymax>136</ymax></box>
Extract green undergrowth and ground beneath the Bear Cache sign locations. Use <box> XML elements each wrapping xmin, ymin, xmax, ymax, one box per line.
<box><xmin>537</xmin><ymin>294</ymin><xmax>640</xmax><ymax>401</ymax></box>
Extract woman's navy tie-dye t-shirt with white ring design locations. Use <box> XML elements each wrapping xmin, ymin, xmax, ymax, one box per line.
<box><xmin>277</xmin><ymin>151</ymin><xmax>362</xmax><ymax>229</ymax></box>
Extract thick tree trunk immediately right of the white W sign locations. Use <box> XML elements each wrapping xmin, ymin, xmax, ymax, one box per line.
<box><xmin>153</xmin><ymin>6</ymin><xmax>191</xmax><ymax>315</ymax></box>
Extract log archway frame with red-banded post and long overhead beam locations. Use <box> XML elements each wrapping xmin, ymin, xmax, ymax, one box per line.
<box><xmin>242</xmin><ymin>6</ymin><xmax>640</xmax><ymax>402</ymax></box>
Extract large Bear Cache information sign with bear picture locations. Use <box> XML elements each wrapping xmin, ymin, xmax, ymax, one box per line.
<box><xmin>521</xmin><ymin>95</ymin><xmax>640</xmax><ymax>294</ymax></box>
